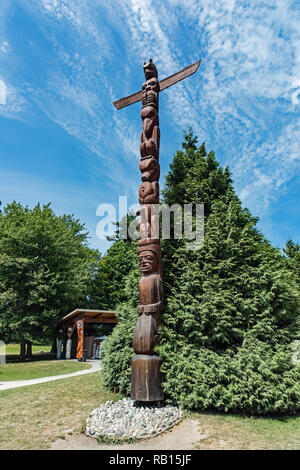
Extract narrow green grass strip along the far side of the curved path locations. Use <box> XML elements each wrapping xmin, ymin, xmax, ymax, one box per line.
<box><xmin>0</xmin><ymin>360</ymin><xmax>91</xmax><ymax>382</ymax></box>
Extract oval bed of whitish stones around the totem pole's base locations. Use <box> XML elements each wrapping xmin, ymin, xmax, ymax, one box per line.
<box><xmin>86</xmin><ymin>398</ymin><xmax>183</xmax><ymax>439</ymax></box>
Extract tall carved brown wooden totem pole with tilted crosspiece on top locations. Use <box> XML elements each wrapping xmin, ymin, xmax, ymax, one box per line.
<box><xmin>114</xmin><ymin>59</ymin><xmax>200</xmax><ymax>402</ymax></box>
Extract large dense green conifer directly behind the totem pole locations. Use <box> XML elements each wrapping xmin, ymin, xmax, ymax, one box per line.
<box><xmin>104</xmin><ymin>131</ymin><xmax>300</xmax><ymax>414</ymax></box>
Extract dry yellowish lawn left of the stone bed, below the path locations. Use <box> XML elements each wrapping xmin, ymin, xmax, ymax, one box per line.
<box><xmin>0</xmin><ymin>372</ymin><xmax>121</xmax><ymax>449</ymax></box>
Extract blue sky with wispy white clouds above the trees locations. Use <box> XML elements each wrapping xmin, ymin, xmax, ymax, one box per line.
<box><xmin>0</xmin><ymin>0</ymin><xmax>300</xmax><ymax>251</ymax></box>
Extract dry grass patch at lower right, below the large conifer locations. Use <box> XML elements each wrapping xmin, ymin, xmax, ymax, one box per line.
<box><xmin>192</xmin><ymin>413</ymin><xmax>300</xmax><ymax>450</ymax></box>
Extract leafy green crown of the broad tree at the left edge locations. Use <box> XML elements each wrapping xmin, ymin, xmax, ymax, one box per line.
<box><xmin>0</xmin><ymin>202</ymin><xmax>95</xmax><ymax>342</ymax></box>
